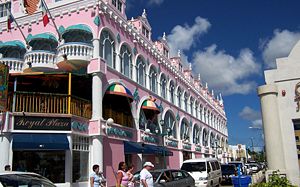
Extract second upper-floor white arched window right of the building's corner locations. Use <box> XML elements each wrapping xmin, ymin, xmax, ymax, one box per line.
<box><xmin>120</xmin><ymin>45</ymin><xmax>132</xmax><ymax>77</ymax></box>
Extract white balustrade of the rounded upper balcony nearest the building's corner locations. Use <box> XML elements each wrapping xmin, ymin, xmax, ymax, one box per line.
<box><xmin>57</xmin><ymin>42</ymin><xmax>93</xmax><ymax>62</ymax></box>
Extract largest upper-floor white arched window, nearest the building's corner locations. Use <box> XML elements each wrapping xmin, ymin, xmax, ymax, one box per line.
<box><xmin>100</xmin><ymin>30</ymin><xmax>116</xmax><ymax>68</ymax></box>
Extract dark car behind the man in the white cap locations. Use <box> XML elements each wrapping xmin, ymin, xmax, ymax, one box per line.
<box><xmin>134</xmin><ymin>169</ymin><xmax>195</xmax><ymax>187</ymax></box>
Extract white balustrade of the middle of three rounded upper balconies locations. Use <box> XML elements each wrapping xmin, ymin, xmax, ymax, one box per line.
<box><xmin>24</xmin><ymin>50</ymin><xmax>56</xmax><ymax>68</ymax></box>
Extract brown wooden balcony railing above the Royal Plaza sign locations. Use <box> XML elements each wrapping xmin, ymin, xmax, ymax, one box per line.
<box><xmin>8</xmin><ymin>92</ymin><xmax>92</xmax><ymax>118</ymax></box>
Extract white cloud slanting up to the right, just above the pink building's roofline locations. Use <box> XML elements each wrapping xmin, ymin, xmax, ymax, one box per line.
<box><xmin>167</xmin><ymin>16</ymin><xmax>211</xmax><ymax>59</ymax></box>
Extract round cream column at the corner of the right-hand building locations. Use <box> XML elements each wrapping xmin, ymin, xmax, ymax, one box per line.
<box><xmin>258</xmin><ymin>85</ymin><xmax>285</xmax><ymax>170</ymax></box>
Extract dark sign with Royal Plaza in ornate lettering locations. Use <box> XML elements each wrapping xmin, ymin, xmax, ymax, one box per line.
<box><xmin>14</xmin><ymin>116</ymin><xmax>71</xmax><ymax>131</ymax></box>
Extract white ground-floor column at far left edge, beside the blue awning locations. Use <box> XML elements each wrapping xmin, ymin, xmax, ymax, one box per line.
<box><xmin>0</xmin><ymin>133</ymin><xmax>12</xmax><ymax>171</ymax></box>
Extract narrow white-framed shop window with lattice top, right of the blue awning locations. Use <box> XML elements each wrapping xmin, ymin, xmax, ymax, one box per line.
<box><xmin>72</xmin><ymin>135</ymin><xmax>89</xmax><ymax>182</ymax></box>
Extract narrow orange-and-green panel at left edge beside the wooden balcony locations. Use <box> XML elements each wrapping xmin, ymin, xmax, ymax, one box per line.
<box><xmin>0</xmin><ymin>63</ymin><xmax>9</xmax><ymax>111</ymax></box>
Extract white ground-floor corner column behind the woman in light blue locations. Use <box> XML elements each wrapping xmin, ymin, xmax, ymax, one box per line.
<box><xmin>91</xmin><ymin>136</ymin><xmax>103</xmax><ymax>171</ymax></box>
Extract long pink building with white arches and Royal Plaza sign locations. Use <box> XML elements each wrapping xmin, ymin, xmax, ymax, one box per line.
<box><xmin>0</xmin><ymin>0</ymin><xmax>228</xmax><ymax>186</ymax></box>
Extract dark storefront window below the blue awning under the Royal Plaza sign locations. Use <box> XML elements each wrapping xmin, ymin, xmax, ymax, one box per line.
<box><xmin>13</xmin><ymin>150</ymin><xmax>65</xmax><ymax>183</ymax></box>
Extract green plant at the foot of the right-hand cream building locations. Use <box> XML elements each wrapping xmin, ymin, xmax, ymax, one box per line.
<box><xmin>251</xmin><ymin>170</ymin><xmax>296</xmax><ymax>187</ymax></box>
